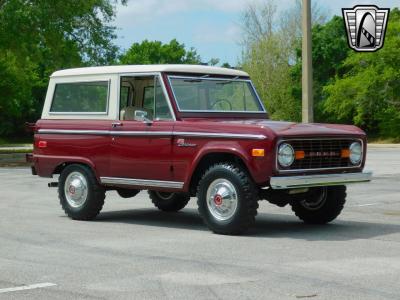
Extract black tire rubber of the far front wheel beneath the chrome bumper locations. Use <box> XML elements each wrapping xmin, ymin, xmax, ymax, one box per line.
<box><xmin>291</xmin><ymin>185</ymin><xmax>346</xmax><ymax>224</ymax></box>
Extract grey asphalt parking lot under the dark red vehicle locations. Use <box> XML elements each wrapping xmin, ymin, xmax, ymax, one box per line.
<box><xmin>0</xmin><ymin>147</ymin><xmax>400</xmax><ymax>300</ymax></box>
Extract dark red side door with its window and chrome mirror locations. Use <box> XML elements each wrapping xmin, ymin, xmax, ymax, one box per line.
<box><xmin>111</xmin><ymin>75</ymin><xmax>173</xmax><ymax>184</ymax></box>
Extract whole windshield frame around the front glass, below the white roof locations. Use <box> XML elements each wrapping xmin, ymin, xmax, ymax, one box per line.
<box><xmin>167</xmin><ymin>74</ymin><xmax>267</xmax><ymax>115</ymax></box>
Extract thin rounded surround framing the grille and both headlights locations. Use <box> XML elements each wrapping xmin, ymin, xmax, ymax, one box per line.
<box><xmin>275</xmin><ymin>137</ymin><xmax>365</xmax><ymax>173</ymax></box>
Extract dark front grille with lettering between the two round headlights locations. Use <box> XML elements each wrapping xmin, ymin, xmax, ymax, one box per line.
<box><xmin>278</xmin><ymin>139</ymin><xmax>359</xmax><ymax>170</ymax></box>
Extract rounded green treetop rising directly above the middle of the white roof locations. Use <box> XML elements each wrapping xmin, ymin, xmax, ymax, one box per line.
<box><xmin>120</xmin><ymin>39</ymin><xmax>201</xmax><ymax>65</ymax></box>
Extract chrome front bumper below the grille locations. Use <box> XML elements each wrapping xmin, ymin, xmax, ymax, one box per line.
<box><xmin>270</xmin><ymin>171</ymin><xmax>372</xmax><ymax>190</ymax></box>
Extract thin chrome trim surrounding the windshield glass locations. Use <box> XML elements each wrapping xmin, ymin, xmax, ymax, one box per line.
<box><xmin>168</xmin><ymin>75</ymin><xmax>267</xmax><ymax>114</ymax></box>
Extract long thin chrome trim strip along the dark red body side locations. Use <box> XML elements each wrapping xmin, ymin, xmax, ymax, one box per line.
<box><xmin>38</xmin><ymin>129</ymin><xmax>267</xmax><ymax>140</ymax></box>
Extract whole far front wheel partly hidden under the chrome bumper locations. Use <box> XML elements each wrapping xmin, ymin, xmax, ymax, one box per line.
<box><xmin>291</xmin><ymin>185</ymin><xmax>346</xmax><ymax>224</ymax></box>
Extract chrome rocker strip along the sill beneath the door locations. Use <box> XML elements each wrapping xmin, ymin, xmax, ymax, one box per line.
<box><xmin>100</xmin><ymin>177</ymin><xmax>184</xmax><ymax>189</ymax></box>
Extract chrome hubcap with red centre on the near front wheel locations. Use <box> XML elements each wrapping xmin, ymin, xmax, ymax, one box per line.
<box><xmin>207</xmin><ymin>178</ymin><xmax>238</xmax><ymax>221</ymax></box>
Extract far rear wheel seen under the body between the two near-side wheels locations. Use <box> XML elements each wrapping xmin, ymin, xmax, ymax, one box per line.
<box><xmin>149</xmin><ymin>191</ymin><xmax>190</xmax><ymax>212</ymax></box>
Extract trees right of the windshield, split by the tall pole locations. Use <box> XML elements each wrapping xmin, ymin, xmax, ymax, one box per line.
<box><xmin>242</xmin><ymin>0</ymin><xmax>400</xmax><ymax>140</ymax></box>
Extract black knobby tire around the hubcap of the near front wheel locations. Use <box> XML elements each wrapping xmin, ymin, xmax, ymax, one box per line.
<box><xmin>197</xmin><ymin>162</ymin><xmax>258</xmax><ymax>235</ymax></box>
